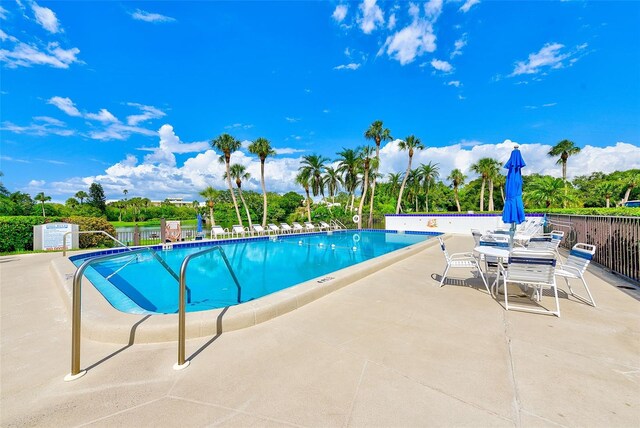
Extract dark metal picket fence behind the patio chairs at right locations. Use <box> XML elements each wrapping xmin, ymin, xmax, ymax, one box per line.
<box><xmin>548</xmin><ymin>214</ymin><xmax>640</xmax><ymax>282</ymax></box>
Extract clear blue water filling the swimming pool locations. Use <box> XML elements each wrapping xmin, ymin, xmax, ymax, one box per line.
<box><xmin>71</xmin><ymin>231</ymin><xmax>434</xmax><ymax>313</ymax></box>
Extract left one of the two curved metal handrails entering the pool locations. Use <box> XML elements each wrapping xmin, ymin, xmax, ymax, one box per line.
<box><xmin>64</xmin><ymin>246</ymin><xmax>181</xmax><ymax>381</ymax></box>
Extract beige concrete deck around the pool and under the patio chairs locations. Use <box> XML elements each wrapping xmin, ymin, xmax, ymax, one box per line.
<box><xmin>0</xmin><ymin>236</ymin><xmax>640</xmax><ymax>427</ymax></box>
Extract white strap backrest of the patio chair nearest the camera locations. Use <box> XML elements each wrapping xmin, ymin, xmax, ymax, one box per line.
<box><xmin>507</xmin><ymin>249</ymin><xmax>556</xmax><ymax>284</ymax></box>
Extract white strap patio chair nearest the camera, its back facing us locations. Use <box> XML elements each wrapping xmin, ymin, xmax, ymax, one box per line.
<box><xmin>500</xmin><ymin>248</ymin><xmax>560</xmax><ymax>317</ymax></box>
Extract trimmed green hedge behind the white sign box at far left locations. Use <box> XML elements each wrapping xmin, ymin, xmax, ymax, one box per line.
<box><xmin>0</xmin><ymin>216</ymin><xmax>116</xmax><ymax>253</ymax></box>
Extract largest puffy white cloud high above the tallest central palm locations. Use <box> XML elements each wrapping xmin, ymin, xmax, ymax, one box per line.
<box><xmin>378</xmin><ymin>4</ymin><xmax>436</xmax><ymax>65</ymax></box>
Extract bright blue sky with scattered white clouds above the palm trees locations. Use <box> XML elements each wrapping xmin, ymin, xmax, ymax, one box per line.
<box><xmin>0</xmin><ymin>0</ymin><xmax>640</xmax><ymax>201</ymax></box>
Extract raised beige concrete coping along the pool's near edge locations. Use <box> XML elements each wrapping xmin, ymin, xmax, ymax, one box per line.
<box><xmin>50</xmin><ymin>235</ymin><xmax>447</xmax><ymax>344</ymax></box>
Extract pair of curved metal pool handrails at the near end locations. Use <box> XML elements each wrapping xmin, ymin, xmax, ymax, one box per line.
<box><xmin>64</xmin><ymin>244</ymin><xmax>241</xmax><ymax>381</ymax></box>
